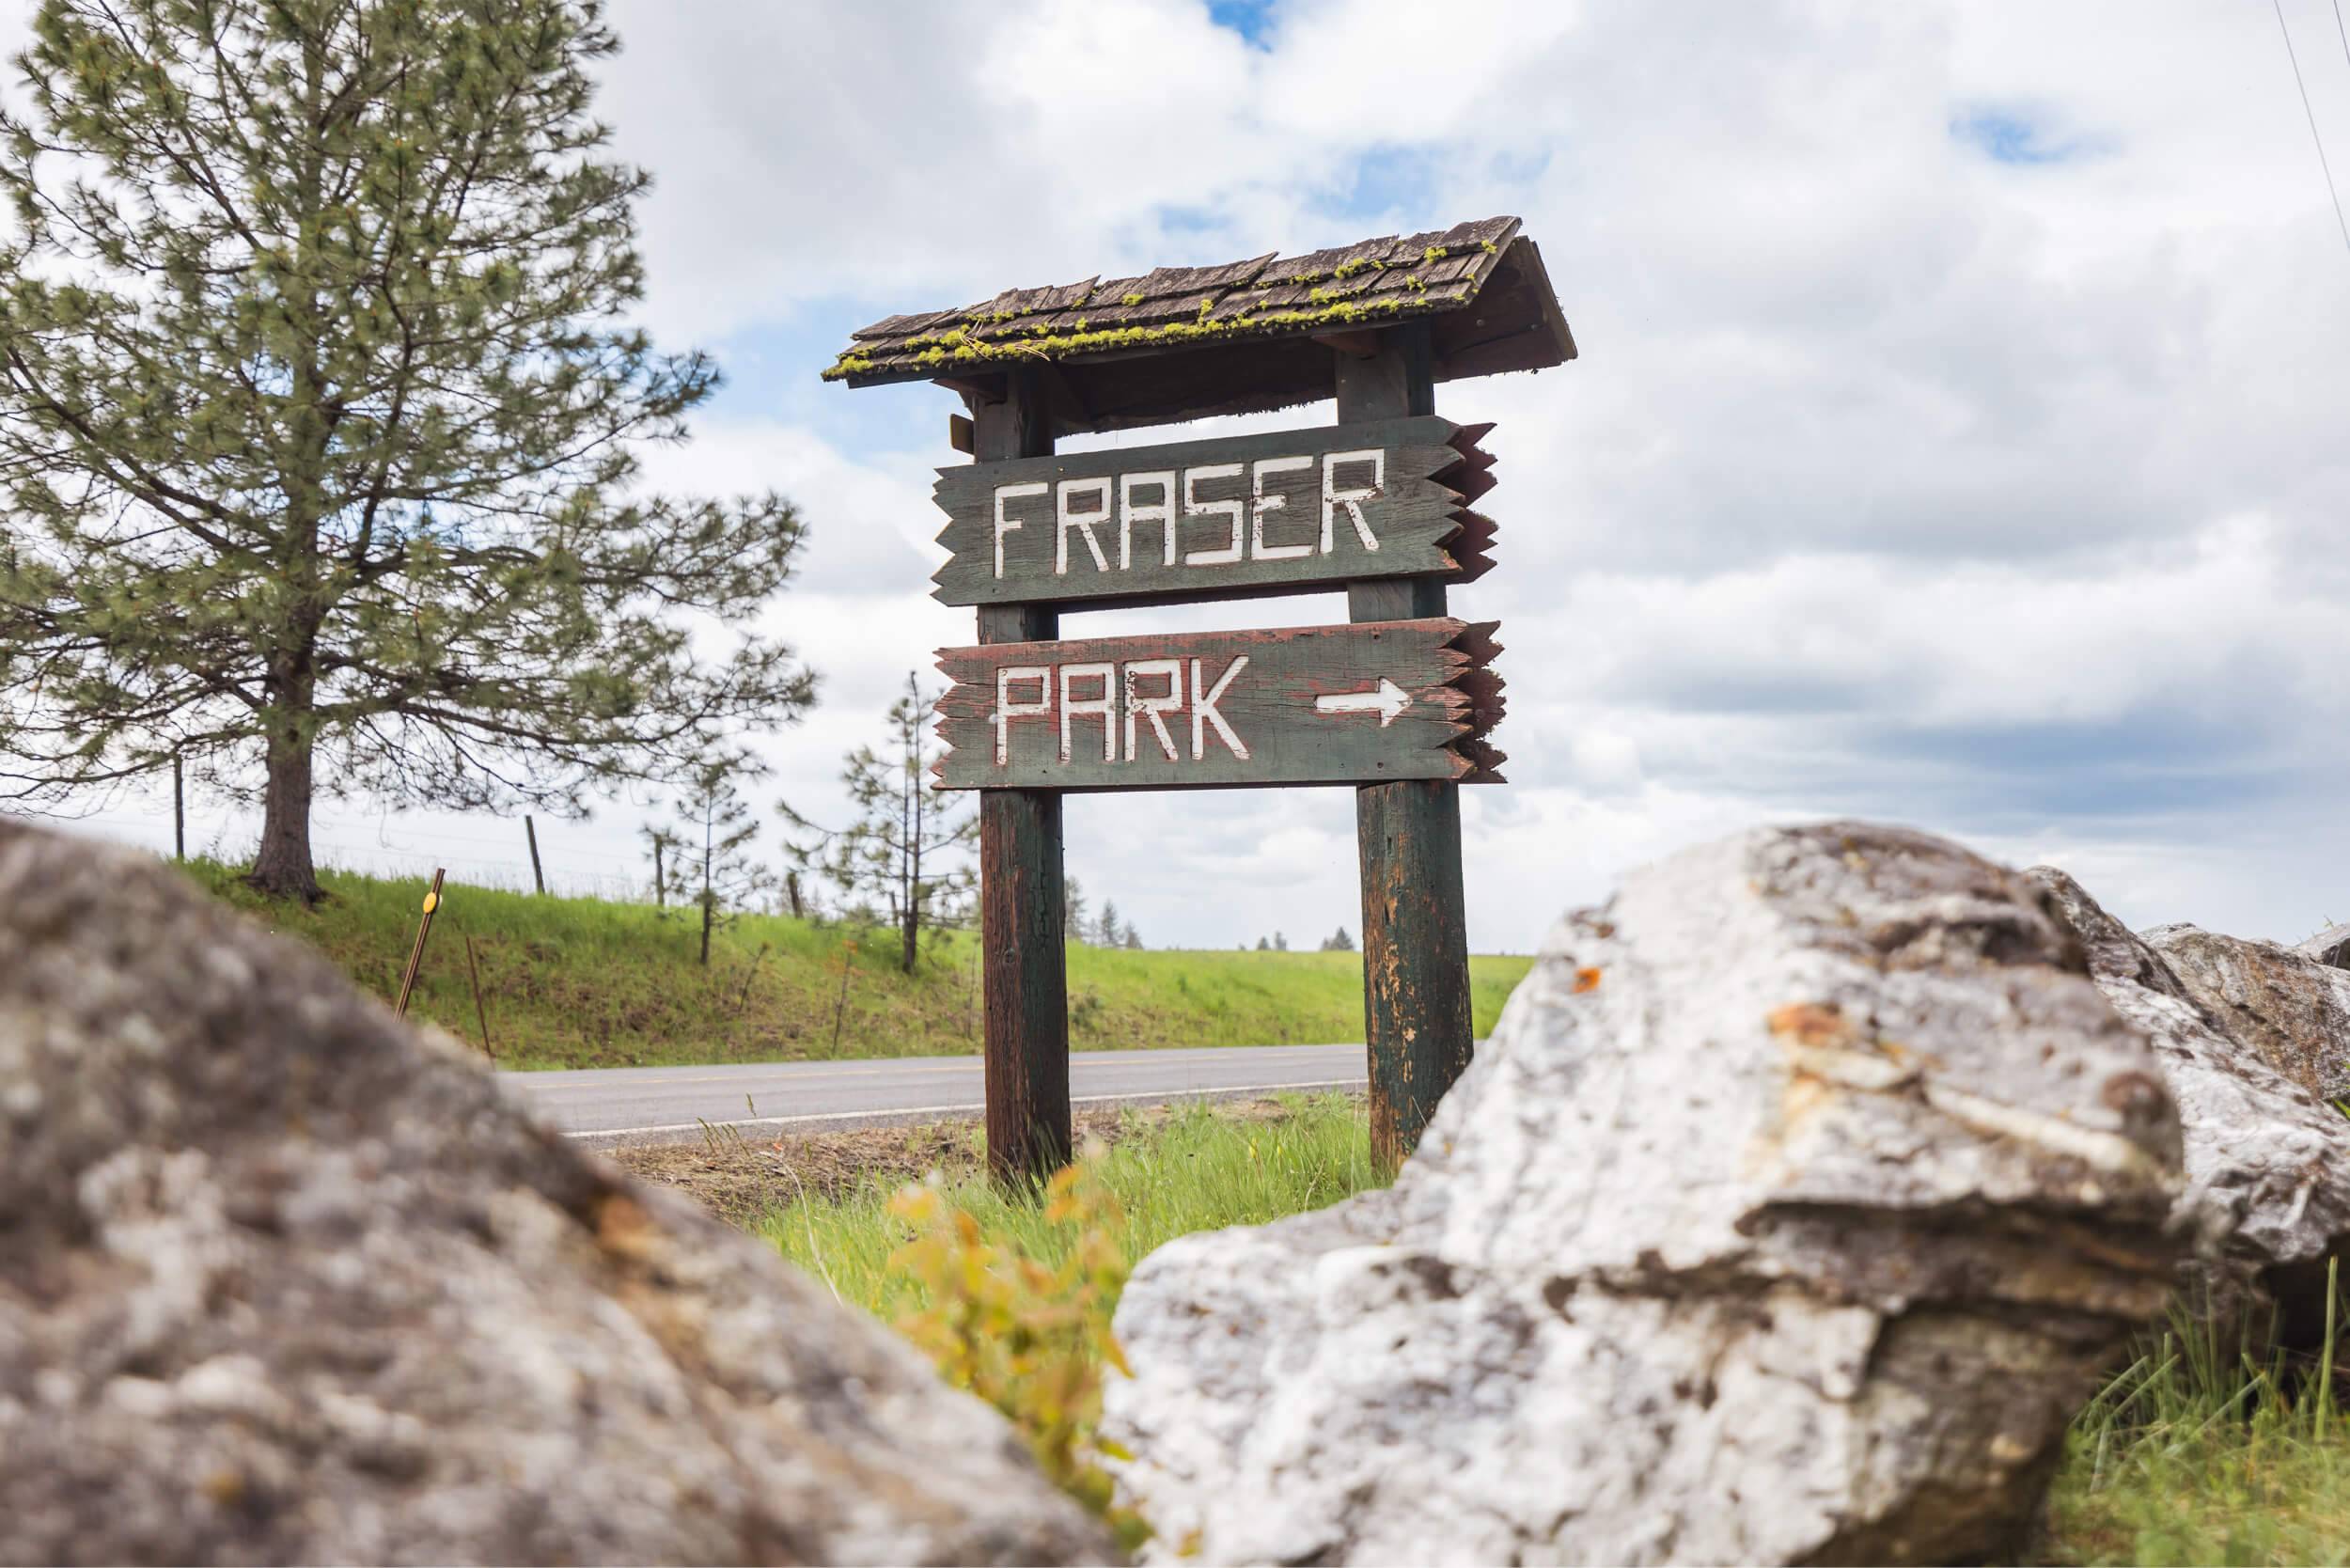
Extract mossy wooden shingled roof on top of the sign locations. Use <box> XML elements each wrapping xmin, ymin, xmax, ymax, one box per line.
<box><xmin>825</xmin><ymin>219</ymin><xmax>1574</xmax><ymax>432</ymax></box>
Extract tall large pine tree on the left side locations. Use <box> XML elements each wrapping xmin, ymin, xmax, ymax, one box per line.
<box><xmin>0</xmin><ymin>0</ymin><xmax>813</xmax><ymax>898</ymax></box>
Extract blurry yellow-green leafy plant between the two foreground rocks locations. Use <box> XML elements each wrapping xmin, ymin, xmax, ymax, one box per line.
<box><xmin>888</xmin><ymin>1161</ymin><xmax>1150</xmax><ymax>1549</ymax></box>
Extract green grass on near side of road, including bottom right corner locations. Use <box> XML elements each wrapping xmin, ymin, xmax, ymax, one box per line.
<box><xmin>733</xmin><ymin>1098</ymin><xmax>2350</xmax><ymax>1563</ymax></box>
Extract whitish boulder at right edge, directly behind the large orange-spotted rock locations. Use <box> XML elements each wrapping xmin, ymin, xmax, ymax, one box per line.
<box><xmin>2026</xmin><ymin>865</ymin><xmax>2350</xmax><ymax>1344</ymax></box>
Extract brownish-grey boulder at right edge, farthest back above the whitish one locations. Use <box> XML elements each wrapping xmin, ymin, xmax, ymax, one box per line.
<box><xmin>2143</xmin><ymin>926</ymin><xmax>2350</xmax><ymax>1100</ymax></box>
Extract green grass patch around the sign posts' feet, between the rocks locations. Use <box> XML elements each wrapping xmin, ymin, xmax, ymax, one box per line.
<box><xmin>755</xmin><ymin>1095</ymin><xmax>1385</xmax><ymax>1321</ymax></box>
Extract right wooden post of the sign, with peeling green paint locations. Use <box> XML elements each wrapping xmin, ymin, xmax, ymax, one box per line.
<box><xmin>1335</xmin><ymin>322</ymin><xmax>1476</xmax><ymax>1168</ymax></box>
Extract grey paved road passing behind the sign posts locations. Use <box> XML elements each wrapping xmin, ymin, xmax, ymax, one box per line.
<box><xmin>498</xmin><ymin>1046</ymin><xmax>1363</xmax><ymax>1147</ymax></box>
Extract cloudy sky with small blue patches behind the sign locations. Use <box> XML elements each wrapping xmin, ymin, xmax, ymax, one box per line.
<box><xmin>9</xmin><ymin>0</ymin><xmax>2350</xmax><ymax>952</ymax></box>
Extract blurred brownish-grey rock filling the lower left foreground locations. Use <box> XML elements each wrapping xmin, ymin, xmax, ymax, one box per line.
<box><xmin>0</xmin><ymin>823</ymin><xmax>1112</xmax><ymax>1563</ymax></box>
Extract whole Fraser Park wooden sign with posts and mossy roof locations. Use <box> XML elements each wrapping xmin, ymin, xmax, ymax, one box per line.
<box><xmin>825</xmin><ymin>219</ymin><xmax>1574</xmax><ymax>1178</ymax></box>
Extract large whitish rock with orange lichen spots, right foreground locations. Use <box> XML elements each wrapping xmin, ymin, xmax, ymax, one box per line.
<box><xmin>1112</xmin><ymin>825</ymin><xmax>2181</xmax><ymax>1563</ymax></box>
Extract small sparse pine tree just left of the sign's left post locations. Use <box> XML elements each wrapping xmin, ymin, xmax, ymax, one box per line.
<box><xmin>778</xmin><ymin>672</ymin><xmax>980</xmax><ymax>973</ymax></box>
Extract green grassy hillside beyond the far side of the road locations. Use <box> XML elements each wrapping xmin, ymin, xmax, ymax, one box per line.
<box><xmin>188</xmin><ymin>860</ymin><xmax>1532</xmax><ymax>1067</ymax></box>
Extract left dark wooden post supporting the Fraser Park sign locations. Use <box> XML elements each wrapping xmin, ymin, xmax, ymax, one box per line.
<box><xmin>971</xmin><ymin>367</ymin><xmax>1070</xmax><ymax>1183</ymax></box>
